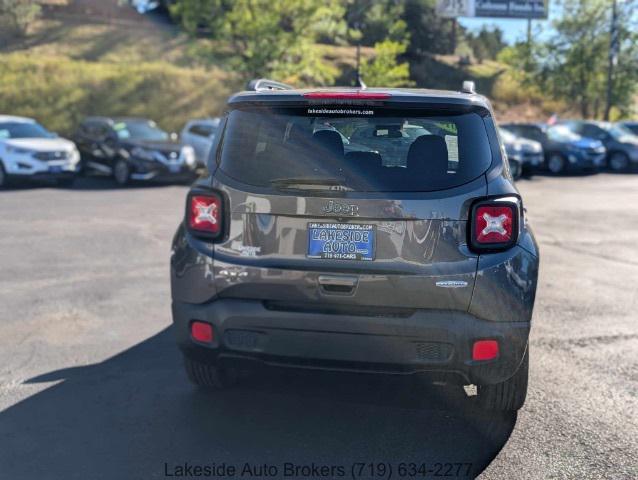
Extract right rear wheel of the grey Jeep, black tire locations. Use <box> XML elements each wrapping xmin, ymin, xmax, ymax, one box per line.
<box><xmin>478</xmin><ymin>346</ymin><xmax>529</xmax><ymax>411</ymax></box>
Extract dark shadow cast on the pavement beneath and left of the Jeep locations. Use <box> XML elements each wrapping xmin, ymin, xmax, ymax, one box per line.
<box><xmin>0</xmin><ymin>328</ymin><xmax>516</xmax><ymax>479</ymax></box>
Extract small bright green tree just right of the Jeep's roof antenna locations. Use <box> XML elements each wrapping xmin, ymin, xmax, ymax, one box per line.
<box><xmin>361</xmin><ymin>40</ymin><xmax>413</xmax><ymax>87</ymax></box>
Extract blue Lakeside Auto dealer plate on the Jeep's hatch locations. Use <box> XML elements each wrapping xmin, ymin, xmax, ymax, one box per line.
<box><xmin>308</xmin><ymin>223</ymin><xmax>375</xmax><ymax>261</ymax></box>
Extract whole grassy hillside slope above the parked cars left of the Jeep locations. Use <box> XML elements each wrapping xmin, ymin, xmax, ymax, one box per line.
<box><xmin>0</xmin><ymin>0</ymin><xmax>238</xmax><ymax>134</ymax></box>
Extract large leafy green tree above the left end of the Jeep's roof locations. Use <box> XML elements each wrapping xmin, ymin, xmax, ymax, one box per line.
<box><xmin>172</xmin><ymin>0</ymin><xmax>345</xmax><ymax>84</ymax></box>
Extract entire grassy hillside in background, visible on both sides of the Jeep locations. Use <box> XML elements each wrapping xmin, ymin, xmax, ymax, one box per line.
<box><xmin>0</xmin><ymin>0</ymin><xmax>552</xmax><ymax>134</ymax></box>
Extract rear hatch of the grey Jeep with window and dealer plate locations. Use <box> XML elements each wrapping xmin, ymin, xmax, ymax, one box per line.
<box><xmin>214</xmin><ymin>99</ymin><xmax>492</xmax><ymax>314</ymax></box>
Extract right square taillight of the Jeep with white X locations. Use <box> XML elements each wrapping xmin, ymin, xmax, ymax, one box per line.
<box><xmin>470</xmin><ymin>200</ymin><xmax>519</xmax><ymax>251</ymax></box>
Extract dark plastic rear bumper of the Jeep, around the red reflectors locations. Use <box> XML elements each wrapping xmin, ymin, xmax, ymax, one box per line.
<box><xmin>173</xmin><ymin>299</ymin><xmax>530</xmax><ymax>385</ymax></box>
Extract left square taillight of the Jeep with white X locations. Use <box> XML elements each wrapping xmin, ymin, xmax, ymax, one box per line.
<box><xmin>186</xmin><ymin>192</ymin><xmax>224</xmax><ymax>239</ymax></box>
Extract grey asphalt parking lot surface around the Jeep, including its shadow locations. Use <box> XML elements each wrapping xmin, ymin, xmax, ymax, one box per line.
<box><xmin>0</xmin><ymin>174</ymin><xmax>638</xmax><ymax>479</ymax></box>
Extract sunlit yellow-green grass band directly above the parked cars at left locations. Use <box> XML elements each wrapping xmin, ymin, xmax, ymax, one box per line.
<box><xmin>0</xmin><ymin>53</ymin><xmax>238</xmax><ymax>135</ymax></box>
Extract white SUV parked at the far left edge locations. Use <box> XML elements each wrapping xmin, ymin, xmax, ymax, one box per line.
<box><xmin>0</xmin><ymin>115</ymin><xmax>80</xmax><ymax>188</ymax></box>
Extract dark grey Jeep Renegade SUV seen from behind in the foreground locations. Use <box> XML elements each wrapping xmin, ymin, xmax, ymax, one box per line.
<box><xmin>171</xmin><ymin>82</ymin><xmax>539</xmax><ymax>410</ymax></box>
